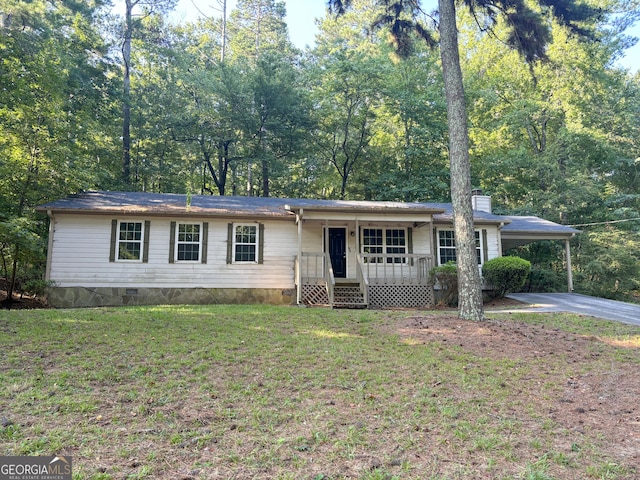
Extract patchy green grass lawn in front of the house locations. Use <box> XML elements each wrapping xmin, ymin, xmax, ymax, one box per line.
<box><xmin>0</xmin><ymin>306</ymin><xmax>640</xmax><ymax>480</ymax></box>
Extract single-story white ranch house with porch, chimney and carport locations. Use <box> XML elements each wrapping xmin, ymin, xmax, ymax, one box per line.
<box><xmin>37</xmin><ymin>191</ymin><xmax>578</xmax><ymax>307</ymax></box>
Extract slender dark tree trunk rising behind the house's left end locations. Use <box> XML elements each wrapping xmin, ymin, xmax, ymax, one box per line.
<box><xmin>122</xmin><ymin>0</ymin><xmax>135</xmax><ymax>185</ymax></box>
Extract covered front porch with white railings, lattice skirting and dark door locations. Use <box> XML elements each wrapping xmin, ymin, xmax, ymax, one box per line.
<box><xmin>291</xmin><ymin>201</ymin><xmax>443</xmax><ymax>308</ymax></box>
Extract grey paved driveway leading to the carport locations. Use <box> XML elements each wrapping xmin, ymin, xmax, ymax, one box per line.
<box><xmin>507</xmin><ymin>293</ymin><xmax>640</xmax><ymax>326</ymax></box>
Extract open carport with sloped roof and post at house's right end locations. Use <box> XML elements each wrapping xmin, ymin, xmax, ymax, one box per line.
<box><xmin>500</xmin><ymin>216</ymin><xmax>580</xmax><ymax>292</ymax></box>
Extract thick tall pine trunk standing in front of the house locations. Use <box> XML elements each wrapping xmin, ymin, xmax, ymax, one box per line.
<box><xmin>438</xmin><ymin>0</ymin><xmax>485</xmax><ymax>320</ymax></box>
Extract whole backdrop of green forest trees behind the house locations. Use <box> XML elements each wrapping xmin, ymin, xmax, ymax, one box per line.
<box><xmin>0</xmin><ymin>0</ymin><xmax>640</xmax><ymax>301</ymax></box>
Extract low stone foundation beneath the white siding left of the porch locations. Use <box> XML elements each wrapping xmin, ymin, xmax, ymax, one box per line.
<box><xmin>48</xmin><ymin>287</ymin><xmax>296</xmax><ymax>308</ymax></box>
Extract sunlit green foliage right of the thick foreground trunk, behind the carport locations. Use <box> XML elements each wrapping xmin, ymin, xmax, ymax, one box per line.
<box><xmin>464</xmin><ymin>2</ymin><xmax>640</xmax><ymax>297</ymax></box>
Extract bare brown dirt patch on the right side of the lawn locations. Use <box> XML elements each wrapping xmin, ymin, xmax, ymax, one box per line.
<box><xmin>393</xmin><ymin>314</ymin><xmax>640</xmax><ymax>478</ymax></box>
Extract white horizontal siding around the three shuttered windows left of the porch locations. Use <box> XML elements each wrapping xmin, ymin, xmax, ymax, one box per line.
<box><xmin>49</xmin><ymin>214</ymin><xmax>297</xmax><ymax>289</ymax></box>
